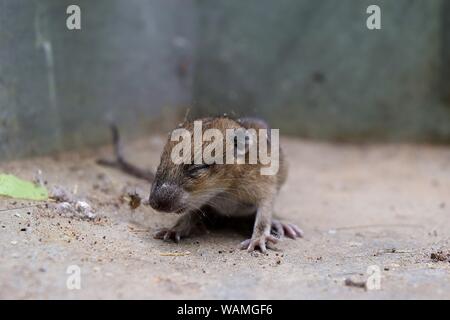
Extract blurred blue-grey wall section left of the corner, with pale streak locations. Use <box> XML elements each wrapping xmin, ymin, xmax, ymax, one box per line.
<box><xmin>0</xmin><ymin>0</ymin><xmax>194</xmax><ymax>160</ymax></box>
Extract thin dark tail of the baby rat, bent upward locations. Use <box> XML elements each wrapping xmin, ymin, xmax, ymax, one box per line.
<box><xmin>97</xmin><ymin>124</ymin><xmax>155</xmax><ymax>182</ymax></box>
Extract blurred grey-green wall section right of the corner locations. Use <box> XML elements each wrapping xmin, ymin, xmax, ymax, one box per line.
<box><xmin>194</xmin><ymin>0</ymin><xmax>450</xmax><ymax>141</ymax></box>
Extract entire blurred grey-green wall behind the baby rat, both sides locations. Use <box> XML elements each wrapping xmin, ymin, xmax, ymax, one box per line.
<box><xmin>0</xmin><ymin>0</ymin><xmax>450</xmax><ymax>160</ymax></box>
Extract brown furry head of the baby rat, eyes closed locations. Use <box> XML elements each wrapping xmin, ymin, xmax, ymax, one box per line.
<box><xmin>149</xmin><ymin>118</ymin><xmax>248</xmax><ymax>213</ymax></box>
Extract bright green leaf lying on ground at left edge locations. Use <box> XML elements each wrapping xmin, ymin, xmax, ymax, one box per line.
<box><xmin>0</xmin><ymin>174</ymin><xmax>48</xmax><ymax>200</ymax></box>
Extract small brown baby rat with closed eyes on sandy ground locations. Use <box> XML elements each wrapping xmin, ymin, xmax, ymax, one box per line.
<box><xmin>98</xmin><ymin>116</ymin><xmax>303</xmax><ymax>253</ymax></box>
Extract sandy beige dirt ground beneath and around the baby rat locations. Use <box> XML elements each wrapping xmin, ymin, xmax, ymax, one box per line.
<box><xmin>0</xmin><ymin>137</ymin><xmax>450</xmax><ymax>299</ymax></box>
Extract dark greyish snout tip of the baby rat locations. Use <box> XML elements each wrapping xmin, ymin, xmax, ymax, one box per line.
<box><xmin>149</xmin><ymin>183</ymin><xmax>181</xmax><ymax>212</ymax></box>
